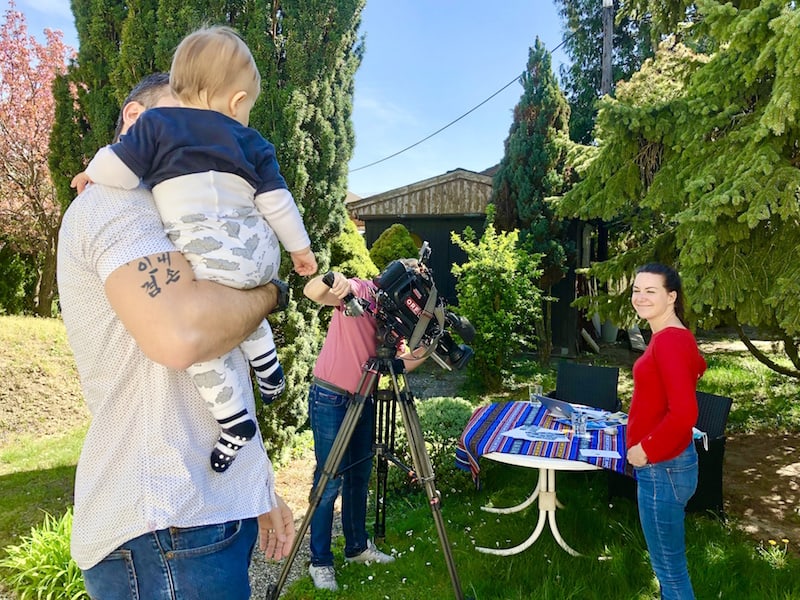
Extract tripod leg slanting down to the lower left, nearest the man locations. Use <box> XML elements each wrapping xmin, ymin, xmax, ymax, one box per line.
<box><xmin>266</xmin><ymin>370</ymin><xmax>378</xmax><ymax>600</ymax></box>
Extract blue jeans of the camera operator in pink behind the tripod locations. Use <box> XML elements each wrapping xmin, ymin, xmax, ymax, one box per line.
<box><xmin>308</xmin><ymin>384</ymin><xmax>375</xmax><ymax>567</ymax></box>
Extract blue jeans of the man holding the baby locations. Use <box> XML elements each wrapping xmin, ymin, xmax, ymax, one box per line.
<box><xmin>83</xmin><ymin>519</ymin><xmax>258</xmax><ymax>600</ymax></box>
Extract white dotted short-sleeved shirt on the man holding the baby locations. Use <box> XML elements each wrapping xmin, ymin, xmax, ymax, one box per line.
<box><xmin>58</xmin><ymin>185</ymin><xmax>276</xmax><ymax>569</ymax></box>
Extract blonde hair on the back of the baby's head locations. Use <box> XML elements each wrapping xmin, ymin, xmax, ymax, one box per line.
<box><xmin>169</xmin><ymin>25</ymin><xmax>261</xmax><ymax>105</ymax></box>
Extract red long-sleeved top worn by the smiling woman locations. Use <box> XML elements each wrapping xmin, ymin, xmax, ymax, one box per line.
<box><xmin>628</xmin><ymin>327</ymin><xmax>706</xmax><ymax>463</ymax></box>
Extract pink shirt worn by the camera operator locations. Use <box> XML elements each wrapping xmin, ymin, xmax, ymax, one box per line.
<box><xmin>314</xmin><ymin>278</ymin><xmax>378</xmax><ymax>393</ymax></box>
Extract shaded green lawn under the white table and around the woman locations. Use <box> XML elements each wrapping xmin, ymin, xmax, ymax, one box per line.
<box><xmin>285</xmin><ymin>461</ymin><xmax>800</xmax><ymax>600</ymax></box>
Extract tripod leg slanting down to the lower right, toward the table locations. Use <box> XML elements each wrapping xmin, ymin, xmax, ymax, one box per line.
<box><xmin>392</xmin><ymin>370</ymin><xmax>464</xmax><ymax>600</ymax></box>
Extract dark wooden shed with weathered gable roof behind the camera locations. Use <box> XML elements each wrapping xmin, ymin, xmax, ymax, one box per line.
<box><xmin>347</xmin><ymin>169</ymin><xmax>492</xmax><ymax>304</ymax></box>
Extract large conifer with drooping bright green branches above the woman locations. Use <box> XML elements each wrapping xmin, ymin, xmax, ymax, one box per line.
<box><xmin>561</xmin><ymin>0</ymin><xmax>800</xmax><ymax>377</ymax></box>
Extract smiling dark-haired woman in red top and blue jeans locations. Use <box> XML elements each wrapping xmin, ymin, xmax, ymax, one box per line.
<box><xmin>628</xmin><ymin>263</ymin><xmax>706</xmax><ymax>600</ymax></box>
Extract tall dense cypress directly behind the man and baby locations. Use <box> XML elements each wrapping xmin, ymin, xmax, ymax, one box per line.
<box><xmin>48</xmin><ymin>0</ymin><xmax>364</xmax><ymax>458</ymax></box>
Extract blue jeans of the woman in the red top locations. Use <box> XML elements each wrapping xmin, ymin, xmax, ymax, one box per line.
<box><xmin>636</xmin><ymin>442</ymin><xmax>697</xmax><ymax>600</ymax></box>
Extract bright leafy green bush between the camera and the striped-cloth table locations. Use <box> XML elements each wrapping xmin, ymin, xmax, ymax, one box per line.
<box><xmin>452</xmin><ymin>224</ymin><xmax>542</xmax><ymax>391</ymax></box>
